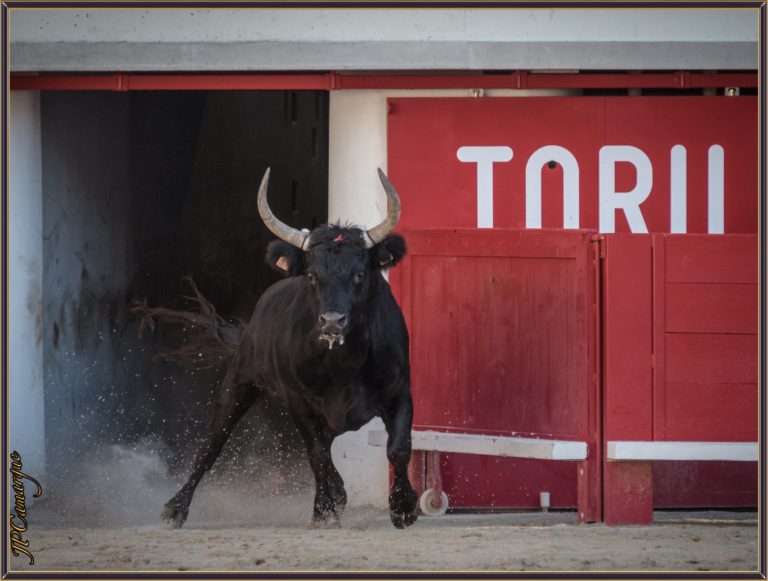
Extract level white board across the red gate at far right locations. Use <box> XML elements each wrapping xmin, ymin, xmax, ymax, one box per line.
<box><xmin>608</xmin><ymin>441</ymin><xmax>758</xmax><ymax>462</ymax></box>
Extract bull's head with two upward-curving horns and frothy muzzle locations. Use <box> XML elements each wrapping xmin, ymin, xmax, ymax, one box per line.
<box><xmin>258</xmin><ymin>169</ymin><xmax>405</xmax><ymax>349</ymax></box>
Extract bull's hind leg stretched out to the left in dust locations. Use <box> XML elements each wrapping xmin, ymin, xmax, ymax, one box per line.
<box><xmin>162</xmin><ymin>379</ymin><xmax>261</xmax><ymax>528</ymax></box>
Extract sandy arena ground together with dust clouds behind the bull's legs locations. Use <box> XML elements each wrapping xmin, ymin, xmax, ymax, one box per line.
<box><xmin>9</xmin><ymin>444</ymin><xmax>758</xmax><ymax>575</ymax></box>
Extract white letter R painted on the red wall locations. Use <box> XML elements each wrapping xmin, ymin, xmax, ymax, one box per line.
<box><xmin>599</xmin><ymin>145</ymin><xmax>653</xmax><ymax>234</ymax></box>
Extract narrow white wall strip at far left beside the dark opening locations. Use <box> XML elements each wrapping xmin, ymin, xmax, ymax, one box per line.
<box><xmin>8</xmin><ymin>91</ymin><xmax>45</xmax><ymax>478</ymax></box>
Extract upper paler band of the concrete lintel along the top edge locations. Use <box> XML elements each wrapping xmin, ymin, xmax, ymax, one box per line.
<box><xmin>10</xmin><ymin>6</ymin><xmax>758</xmax><ymax>43</ymax></box>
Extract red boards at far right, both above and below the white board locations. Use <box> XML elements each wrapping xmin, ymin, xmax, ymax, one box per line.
<box><xmin>654</xmin><ymin>235</ymin><xmax>758</xmax><ymax>507</ymax></box>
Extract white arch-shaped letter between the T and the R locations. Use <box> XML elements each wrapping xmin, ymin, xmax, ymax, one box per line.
<box><xmin>525</xmin><ymin>145</ymin><xmax>579</xmax><ymax>229</ymax></box>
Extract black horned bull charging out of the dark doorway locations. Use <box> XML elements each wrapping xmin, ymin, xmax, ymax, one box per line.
<box><xmin>162</xmin><ymin>170</ymin><xmax>418</xmax><ymax>528</ymax></box>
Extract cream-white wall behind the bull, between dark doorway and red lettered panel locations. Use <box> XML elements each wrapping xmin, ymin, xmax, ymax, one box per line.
<box><xmin>328</xmin><ymin>90</ymin><xmax>568</xmax><ymax>505</ymax></box>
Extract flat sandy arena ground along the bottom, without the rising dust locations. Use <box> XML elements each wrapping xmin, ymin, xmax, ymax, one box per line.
<box><xmin>10</xmin><ymin>498</ymin><xmax>758</xmax><ymax>572</ymax></box>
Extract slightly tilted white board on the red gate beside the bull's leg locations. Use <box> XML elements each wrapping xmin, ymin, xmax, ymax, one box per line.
<box><xmin>368</xmin><ymin>430</ymin><xmax>587</xmax><ymax>460</ymax></box>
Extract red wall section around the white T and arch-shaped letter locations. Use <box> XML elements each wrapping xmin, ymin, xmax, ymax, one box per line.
<box><xmin>388</xmin><ymin>98</ymin><xmax>605</xmax><ymax>228</ymax></box>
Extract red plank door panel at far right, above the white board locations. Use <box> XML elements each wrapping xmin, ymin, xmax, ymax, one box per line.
<box><xmin>654</xmin><ymin>235</ymin><xmax>758</xmax><ymax>441</ymax></box>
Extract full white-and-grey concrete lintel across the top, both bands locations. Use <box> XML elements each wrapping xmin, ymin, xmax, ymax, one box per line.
<box><xmin>10</xmin><ymin>6</ymin><xmax>759</xmax><ymax>72</ymax></box>
